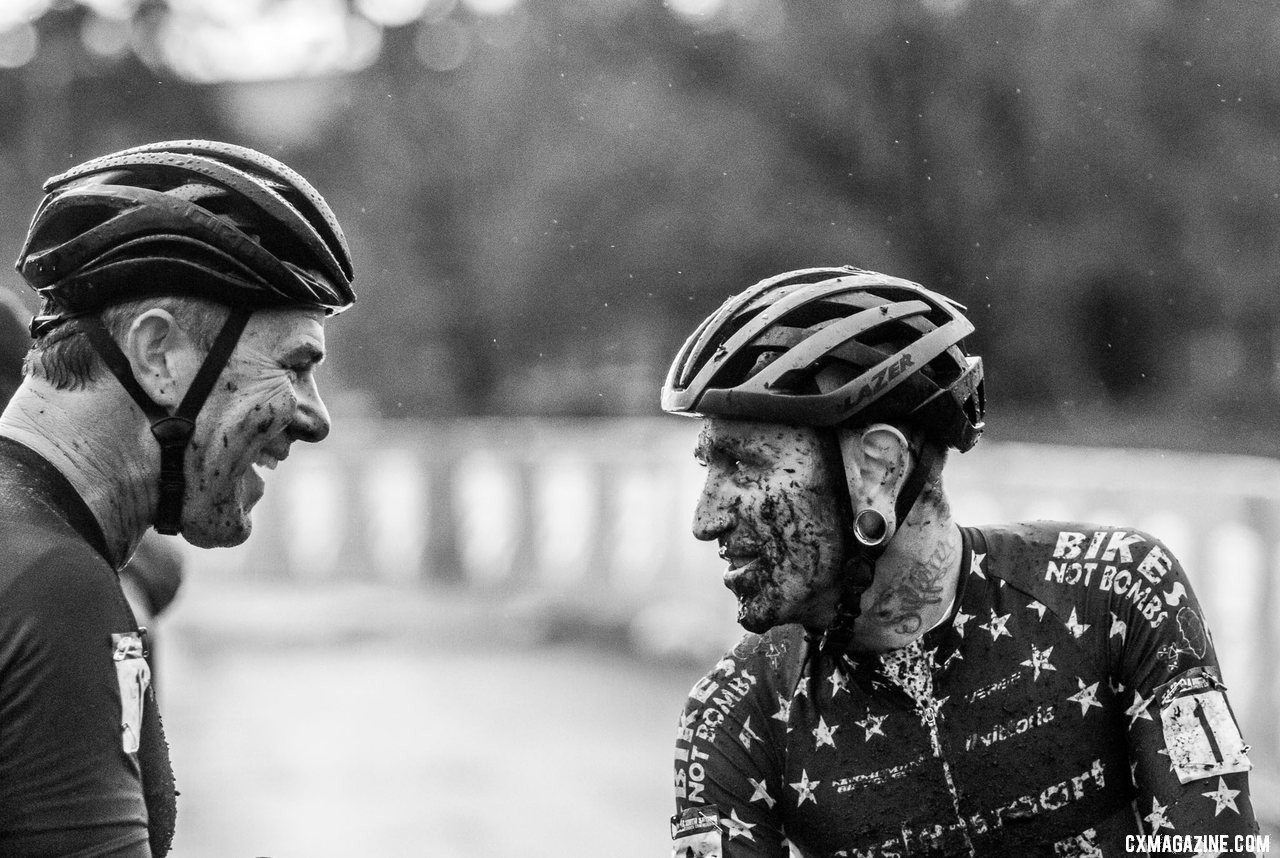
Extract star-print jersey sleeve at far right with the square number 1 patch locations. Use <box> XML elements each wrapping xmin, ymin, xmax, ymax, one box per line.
<box><xmin>1110</xmin><ymin>539</ymin><xmax>1257</xmax><ymax>841</ymax></box>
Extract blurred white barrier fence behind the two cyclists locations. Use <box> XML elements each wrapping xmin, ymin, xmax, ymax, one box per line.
<box><xmin>183</xmin><ymin>417</ymin><xmax>1280</xmax><ymax>822</ymax></box>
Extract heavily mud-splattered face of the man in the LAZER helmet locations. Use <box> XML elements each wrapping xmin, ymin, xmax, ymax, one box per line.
<box><xmin>694</xmin><ymin>419</ymin><xmax>844</xmax><ymax>633</ymax></box>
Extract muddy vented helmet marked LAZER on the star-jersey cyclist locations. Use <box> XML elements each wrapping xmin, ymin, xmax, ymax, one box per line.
<box><xmin>662</xmin><ymin>266</ymin><xmax>986</xmax><ymax>452</ymax></box>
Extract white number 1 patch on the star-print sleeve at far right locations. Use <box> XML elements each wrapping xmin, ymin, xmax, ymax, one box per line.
<box><xmin>1160</xmin><ymin>670</ymin><xmax>1253</xmax><ymax>784</ymax></box>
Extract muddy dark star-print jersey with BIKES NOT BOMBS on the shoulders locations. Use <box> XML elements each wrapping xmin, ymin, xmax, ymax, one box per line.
<box><xmin>672</xmin><ymin>521</ymin><xmax>1257</xmax><ymax>858</ymax></box>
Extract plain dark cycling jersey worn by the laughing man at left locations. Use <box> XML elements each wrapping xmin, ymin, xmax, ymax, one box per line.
<box><xmin>0</xmin><ymin>438</ymin><xmax>174</xmax><ymax>858</ymax></box>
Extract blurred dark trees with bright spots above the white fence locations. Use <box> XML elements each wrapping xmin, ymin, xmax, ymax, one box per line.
<box><xmin>0</xmin><ymin>0</ymin><xmax>1280</xmax><ymax>455</ymax></box>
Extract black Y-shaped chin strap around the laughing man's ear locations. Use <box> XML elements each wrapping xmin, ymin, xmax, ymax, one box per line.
<box><xmin>82</xmin><ymin>307</ymin><xmax>253</xmax><ymax>535</ymax></box>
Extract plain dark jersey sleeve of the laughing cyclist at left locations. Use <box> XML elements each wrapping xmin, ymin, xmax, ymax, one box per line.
<box><xmin>0</xmin><ymin>548</ymin><xmax>151</xmax><ymax>858</ymax></box>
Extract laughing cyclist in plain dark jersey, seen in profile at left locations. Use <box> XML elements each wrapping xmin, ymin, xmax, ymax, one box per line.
<box><xmin>0</xmin><ymin>141</ymin><xmax>355</xmax><ymax>858</ymax></box>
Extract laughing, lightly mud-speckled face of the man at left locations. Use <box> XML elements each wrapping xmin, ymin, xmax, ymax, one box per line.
<box><xmin>182</xmin><ymin>309</ymin><xmax>329</xmax><ymax>548</ymax></box>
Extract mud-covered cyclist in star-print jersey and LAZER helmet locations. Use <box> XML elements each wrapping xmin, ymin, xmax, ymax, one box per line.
<box><xmin>662</xmin><ymin>268</ymin><xmax>1257</xmax><ymax>858</ymax></box>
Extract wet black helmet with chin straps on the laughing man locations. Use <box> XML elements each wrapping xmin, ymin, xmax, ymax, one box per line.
<box><xmin>17</xmin><ymin>140</ymin><xmax>356</xmax><ymax>533</ymax></box>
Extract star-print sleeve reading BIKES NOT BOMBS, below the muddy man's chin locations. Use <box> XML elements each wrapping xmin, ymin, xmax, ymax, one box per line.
<box><xmin>671</xmin><ymin>647</ymin><xmax>788</xmax><ymax>858</ymax></box>
